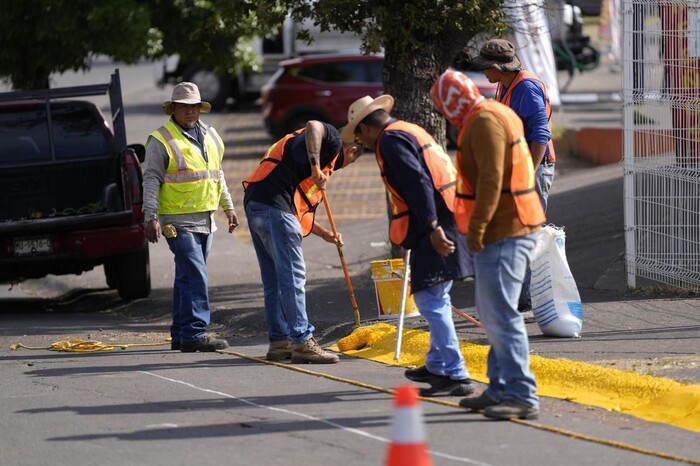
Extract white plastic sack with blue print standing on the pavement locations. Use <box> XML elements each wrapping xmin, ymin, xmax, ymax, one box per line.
<box><xmin>530</xmin><ymin>225</ymin><xmax>583</xmax><ymax>338</ymax></box>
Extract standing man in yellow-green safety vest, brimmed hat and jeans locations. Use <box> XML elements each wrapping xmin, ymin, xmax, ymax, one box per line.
<box><xmin>143</xmin><ymin>82</ymin><xmax>238</xmax><ymax>353</ymax></box>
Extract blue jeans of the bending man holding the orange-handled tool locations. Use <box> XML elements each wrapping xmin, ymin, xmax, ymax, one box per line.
<box><xmin>245</xmin><ymin>202</ymin><xmax>314</xmax><ymax>343</ymax></box>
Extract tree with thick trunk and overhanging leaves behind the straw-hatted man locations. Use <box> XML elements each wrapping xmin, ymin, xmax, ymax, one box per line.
<box><xmin>268</xmin><ymin>0</ymin><xmax>503</xmax><ymax>143</ymax></box>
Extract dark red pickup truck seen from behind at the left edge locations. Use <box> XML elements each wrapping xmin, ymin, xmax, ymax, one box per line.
<box><xmin>0</xmin><ymin>70</ymin><xmax>151</xmax><ymax>300</ymax></box>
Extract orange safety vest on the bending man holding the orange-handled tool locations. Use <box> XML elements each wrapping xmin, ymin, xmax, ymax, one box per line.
<box><xmin>243</xmin><ymin>128</ymin><xmax>338</xmax><ymax>236</ymax></box>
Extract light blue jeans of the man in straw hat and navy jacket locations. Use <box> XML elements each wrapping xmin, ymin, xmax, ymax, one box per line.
<box><xmin>413</xmin><ymin>280</ymin><xmax>469</xmax><ymax>380</ymax></box>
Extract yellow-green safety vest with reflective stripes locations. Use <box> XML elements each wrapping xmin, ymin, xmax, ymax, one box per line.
<box><xmin>151</xmin><ymin>121</ymin><xmax>224</xmax><ymax>214</ymax></box>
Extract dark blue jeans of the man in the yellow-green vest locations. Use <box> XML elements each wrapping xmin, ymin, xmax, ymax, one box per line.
<box><xmin>166</xmin><ymin>229</ymin><xmax>212</xmax><ymax>342</ymax></box>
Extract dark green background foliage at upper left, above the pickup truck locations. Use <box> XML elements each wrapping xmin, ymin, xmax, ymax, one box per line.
<box><xmin>0</xmin><ymin>0</ymin><xmax>286</xmax><ymax>89</ymax></box>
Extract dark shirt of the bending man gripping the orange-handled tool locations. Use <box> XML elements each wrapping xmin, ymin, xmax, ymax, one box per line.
<box><xmin>243</xmin><ymin>123</ymin><xmax>343</xmax><ymax>214</ymax></box>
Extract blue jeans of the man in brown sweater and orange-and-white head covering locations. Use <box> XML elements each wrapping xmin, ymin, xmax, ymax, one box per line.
<box><xmin>474</xmin><ymin>233</ymin><xmax>539</xmax><ymax>407</ymax></box>
